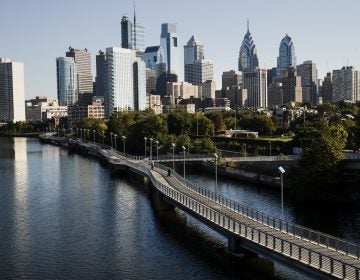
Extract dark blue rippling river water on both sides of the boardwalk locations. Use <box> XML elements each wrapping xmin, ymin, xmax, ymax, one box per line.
<box><xmin>0</xmin><ymin>138</ymin><xmax>360</xmax><ymax>279</ymax></box>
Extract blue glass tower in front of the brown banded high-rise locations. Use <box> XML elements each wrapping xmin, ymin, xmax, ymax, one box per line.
<box><xmin>56</xmin><ymin>57</ymin><xmax>78</xmax><ymax>106</ymax></box>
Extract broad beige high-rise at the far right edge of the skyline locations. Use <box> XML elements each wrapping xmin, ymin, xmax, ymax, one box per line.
<box><xmin>332</xmin><ymin>66</ymin><xmax>360</xmax><ymax>103</ymax></box>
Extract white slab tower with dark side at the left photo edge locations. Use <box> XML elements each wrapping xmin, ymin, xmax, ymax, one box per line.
<box><xmin>0</xmin><ymin>58</ymin><xmax>25</xmax><ymax>122</ymax></box>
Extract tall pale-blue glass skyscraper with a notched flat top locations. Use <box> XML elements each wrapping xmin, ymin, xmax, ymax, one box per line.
<box><xmin>160</xmin><ymin>23</ymin><xmax>180</xmax><ymax>80</ymax></box>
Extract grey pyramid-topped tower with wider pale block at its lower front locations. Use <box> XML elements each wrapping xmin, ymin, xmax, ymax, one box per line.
<box><xmin>184</xmin><ymin>35</ymin><xmax>214</xmax><ymax>85</ymax></box>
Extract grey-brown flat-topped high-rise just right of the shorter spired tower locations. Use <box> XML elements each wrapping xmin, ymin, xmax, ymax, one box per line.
<box><xmin>296</xmin><ymin>60</ymin><xmax>318</xmax><ymax>104</ymax></box>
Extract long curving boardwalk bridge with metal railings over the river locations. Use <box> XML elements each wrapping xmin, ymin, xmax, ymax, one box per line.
<box><xmin>40</xmin><ymin>135</ymin><xmax>360</xmax><ymax>280</ymax></box>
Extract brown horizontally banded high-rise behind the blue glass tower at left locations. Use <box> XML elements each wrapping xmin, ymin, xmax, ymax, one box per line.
<box><xmin>66</xmin><ymin>47</ymin><xmax>94</xmax><ymax>97</ymax></box>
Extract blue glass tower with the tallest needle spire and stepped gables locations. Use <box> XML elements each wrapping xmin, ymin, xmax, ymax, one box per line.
<box><xmin>239</xmin><ymin>21</ymin><xmax>259</xmax><ymax>71</ymax></box>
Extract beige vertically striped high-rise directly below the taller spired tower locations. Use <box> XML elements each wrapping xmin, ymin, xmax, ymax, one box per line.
<box><xmin>243</xmin><ymin>68</ymin><xmax>268</xmax><ymax>108</ymax></box>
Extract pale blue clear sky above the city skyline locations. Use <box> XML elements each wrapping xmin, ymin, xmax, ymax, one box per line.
<box><xmin>0</xmin><ymin>0</ymin><xmax>360</xmax><ymax>98</ymax></box>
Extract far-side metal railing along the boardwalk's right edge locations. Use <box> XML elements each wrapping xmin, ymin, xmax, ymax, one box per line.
<box><xmin>155</xmin><ymin>164</ymin><xmax>360</xmax><ymax>259</ymax></box>
